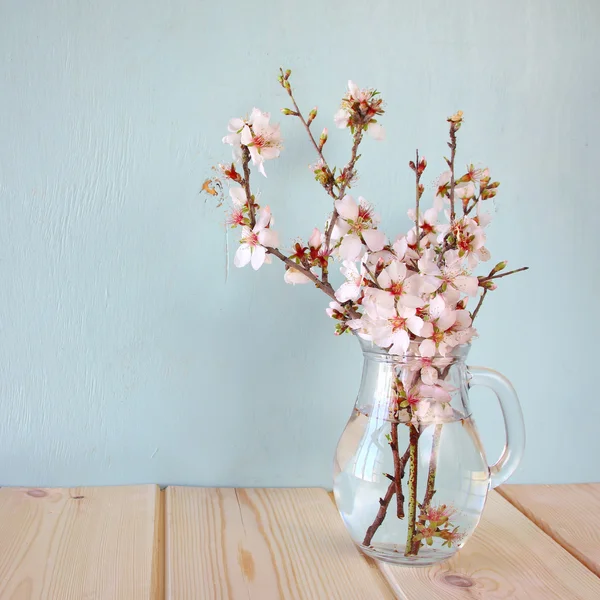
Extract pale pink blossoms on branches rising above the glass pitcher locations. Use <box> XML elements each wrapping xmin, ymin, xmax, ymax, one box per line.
<box><xmin>213</xmin><ymin>71</ymin><xmax>524</xmax><ymax>376</ymax></box>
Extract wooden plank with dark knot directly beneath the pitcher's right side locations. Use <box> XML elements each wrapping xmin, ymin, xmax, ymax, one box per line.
<box><xmin>381</xmin><ymin>491</ymin><xmax>600</xmax><ymax>600</ymax></box>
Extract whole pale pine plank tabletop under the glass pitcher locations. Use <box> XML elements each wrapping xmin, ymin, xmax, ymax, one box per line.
<box><xmin>0</xmin><ymin>484</ymin><xmax>600</xmax><ymax>600</ymax></box>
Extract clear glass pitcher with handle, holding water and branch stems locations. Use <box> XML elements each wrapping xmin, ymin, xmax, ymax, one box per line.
<box><xmin>333</xmin><ymin>340</ymin><xmax>525</xmax><ymax>566</ymax></box>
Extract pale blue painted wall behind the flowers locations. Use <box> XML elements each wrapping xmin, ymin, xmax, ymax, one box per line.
<box><xmin>0</xmin><ymin>0</ymin><xmax>600</xmax><ymax>486</ymax></box>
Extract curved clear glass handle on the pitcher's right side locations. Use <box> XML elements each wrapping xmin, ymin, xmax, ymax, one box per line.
<box><xmin>468</xmin><ymin>367</ymin><xmax>525</xmax><ymax>488</ymax></box>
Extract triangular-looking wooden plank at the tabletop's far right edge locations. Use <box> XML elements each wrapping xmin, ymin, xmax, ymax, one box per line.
<box><xmin>498</xmin><ymin>483</ymin><xmax>600</xmax><ymax>577</ymax></box>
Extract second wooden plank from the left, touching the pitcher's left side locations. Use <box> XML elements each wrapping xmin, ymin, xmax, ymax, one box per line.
<box><xmin>166</xmin><ymin>487</ymin><xmax>393</xmax><ymax>600</ymax></box>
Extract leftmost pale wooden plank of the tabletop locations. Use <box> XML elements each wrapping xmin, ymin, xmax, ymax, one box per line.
<box><xmin>0</xmin><ymin>485</ymin><xmax>161</xmax><ymax>600</ymax></box>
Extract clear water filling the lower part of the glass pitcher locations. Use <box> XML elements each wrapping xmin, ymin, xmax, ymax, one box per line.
<box><xmin>334</xmin><ymin>409</ymin><xmax>490</xmax><ymax>565</ymax></box>
